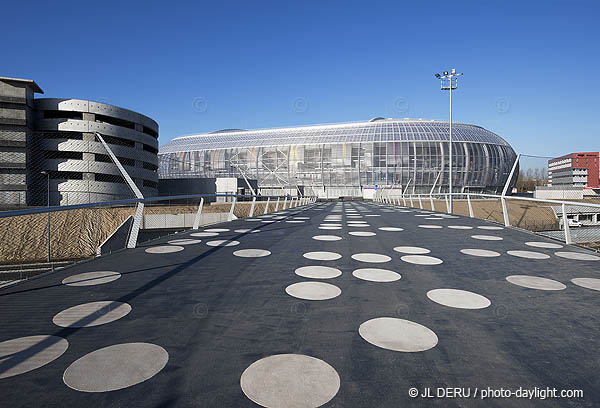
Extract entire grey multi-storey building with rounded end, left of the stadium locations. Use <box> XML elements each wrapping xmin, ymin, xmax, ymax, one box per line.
<box><xmin>0</xmin><ymin>77</ymin><xmax>158</xmax><ymax>207</ymax></box>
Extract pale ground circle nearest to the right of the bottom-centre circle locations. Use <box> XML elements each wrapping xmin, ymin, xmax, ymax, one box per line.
<box><xmin>358</xmin><ymin>317</ymin><xmax>438</xmax><ymax>353</ymax></box>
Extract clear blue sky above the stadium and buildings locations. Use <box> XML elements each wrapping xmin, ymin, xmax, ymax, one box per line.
<box><xmin>0</xmin><ymin>0</ymin><xmax>600</xmax><ymax>156</ymax></box>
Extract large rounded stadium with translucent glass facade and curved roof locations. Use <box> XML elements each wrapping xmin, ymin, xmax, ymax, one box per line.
<box><xmin>159</xmin><ymin>118</ymin><xmax>516</xmax><ymax>197</ymax></box>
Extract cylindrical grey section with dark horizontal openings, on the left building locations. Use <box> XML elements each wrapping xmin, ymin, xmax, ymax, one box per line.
<box><xmin>28</xmin><ymin>98</ymin><xmax>158</xmax><ymax>205</ymax></box>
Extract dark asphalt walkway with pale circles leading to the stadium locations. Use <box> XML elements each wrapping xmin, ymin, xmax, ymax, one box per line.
<box><xmin>0</xmin><ymin>202</ymin><xmax>600</xmax><ymax>407</ymax></box>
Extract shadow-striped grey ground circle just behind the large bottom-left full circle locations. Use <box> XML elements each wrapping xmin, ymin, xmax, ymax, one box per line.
<box><xmin>52</xmin><ymin>300</ymin><xmax>131</xmax><ymax>327</ymax></box>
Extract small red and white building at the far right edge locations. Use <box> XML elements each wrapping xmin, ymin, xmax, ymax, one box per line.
<box><xmin>548</xmin><ymin>152</ymin><xmax>599</xmax><ymax>188</ymax></box>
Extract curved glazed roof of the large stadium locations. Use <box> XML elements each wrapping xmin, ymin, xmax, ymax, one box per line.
<box><xmin>159</xmin><ymin>118</ymin><xmax>510</xmax><ymax>153</ymax></box>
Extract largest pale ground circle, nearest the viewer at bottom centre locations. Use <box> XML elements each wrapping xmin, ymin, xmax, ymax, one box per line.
<box><xmin>240</xmin><ymin>354</ymin><xmax>340</xmax><ymax>408</ymax></box>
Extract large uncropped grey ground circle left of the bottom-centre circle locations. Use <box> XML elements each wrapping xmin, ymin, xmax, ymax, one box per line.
<box><xmin>63</xmin><ymin>343</ymin><xmax>169</xmax><ymax>392</ymax></box>
